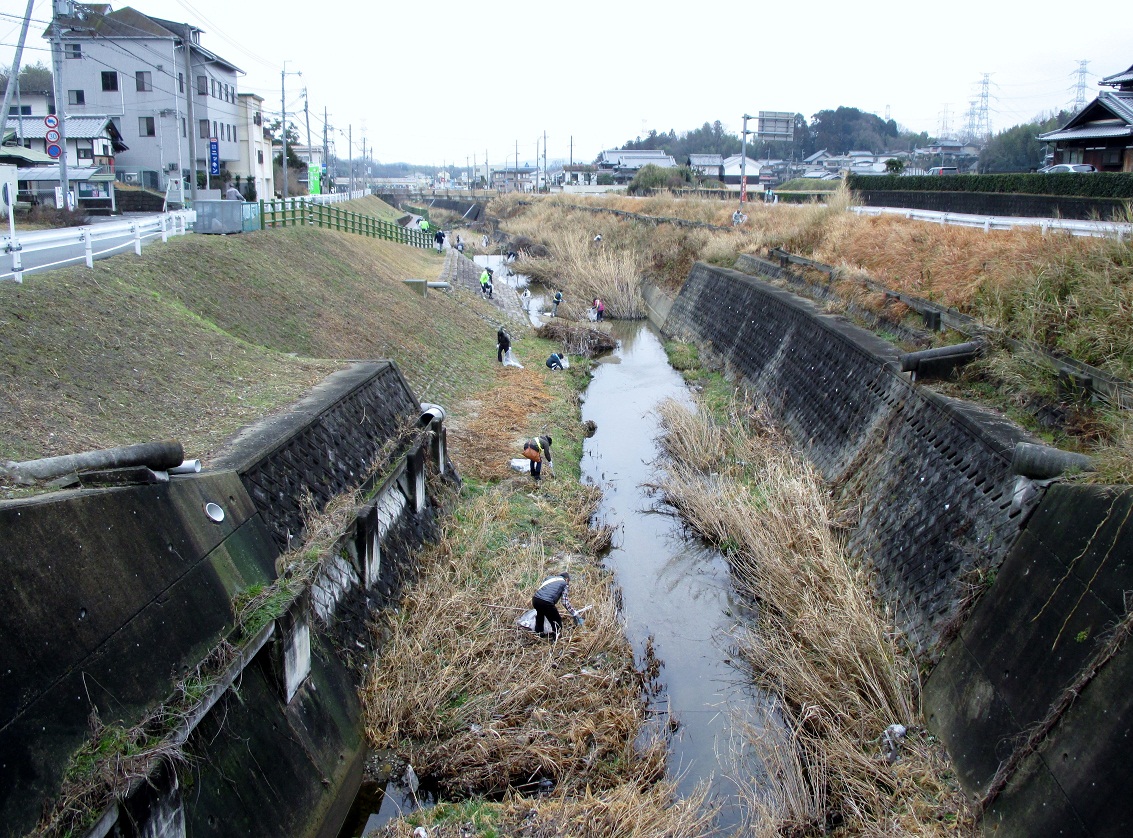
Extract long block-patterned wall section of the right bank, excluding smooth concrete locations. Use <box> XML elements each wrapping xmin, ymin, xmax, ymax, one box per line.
<box><xmin>664</xmin><ymin>264</ymin><xmax>1034</xmax><ymax>659</ymax></box>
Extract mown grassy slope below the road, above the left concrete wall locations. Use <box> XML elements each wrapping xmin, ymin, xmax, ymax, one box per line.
<box><xmin>0</xmin><ymin>228</ymin><xmax>509</xmax><ymax>460</ymax></box>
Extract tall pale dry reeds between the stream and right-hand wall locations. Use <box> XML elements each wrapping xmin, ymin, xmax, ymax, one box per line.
<box><xmin>656</xmin><ymin>402</ymin><xmax>971</xmax><ymax>835</ymax></box>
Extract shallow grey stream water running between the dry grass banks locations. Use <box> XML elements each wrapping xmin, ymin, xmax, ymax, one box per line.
<box><xmin>582</xmin><ymin>322</ymin><xmax>763</xmax><ymax>833</ymax></box>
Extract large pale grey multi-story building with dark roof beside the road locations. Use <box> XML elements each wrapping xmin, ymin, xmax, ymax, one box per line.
<box><xmin>45</xmin><ymin>3</ymin><xmax>244</xmax><ymax>189</ymax></box>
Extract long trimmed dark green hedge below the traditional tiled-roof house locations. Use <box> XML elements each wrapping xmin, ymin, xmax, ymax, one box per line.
<box><xmin>849</xmin><ymin>172</ymin><xmax>1133</xmax><ymax>198</ymax></box>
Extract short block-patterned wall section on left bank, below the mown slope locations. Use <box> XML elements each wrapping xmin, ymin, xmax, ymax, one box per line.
<box><xmin>211</xmin><ymin>361</ymin><xmax>420</xmax><ymax>551</ymax></box>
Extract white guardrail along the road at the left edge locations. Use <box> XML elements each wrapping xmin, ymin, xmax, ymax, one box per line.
<box><xmin>0</xmin><ymin>210</ymin><xmax>197</xmax><ymax>282</ymax></box>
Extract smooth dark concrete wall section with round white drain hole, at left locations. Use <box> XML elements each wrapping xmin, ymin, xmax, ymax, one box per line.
<box><xmin>0</xmin><ymin>472</ymin><xmax>275</xmax><ymax>836</ymax></box>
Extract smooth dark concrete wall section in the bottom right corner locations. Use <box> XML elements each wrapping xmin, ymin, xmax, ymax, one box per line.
<box><xmin>925</xmin><ymin>485</ymin><xmax>1133</xmax><ymax>837</ymax></box>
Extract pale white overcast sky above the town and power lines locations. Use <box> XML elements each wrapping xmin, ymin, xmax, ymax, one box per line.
<box><xmin>0</xmin><ymin>0</ymin><xmax>1133</xmax><ymax>165</ymax></box>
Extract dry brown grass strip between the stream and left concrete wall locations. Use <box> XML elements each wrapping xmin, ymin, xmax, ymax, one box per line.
<box><xmin>363</xmin><ymin>341</ymin><xmax>713</xmax><ymax>838</ymax></box>
